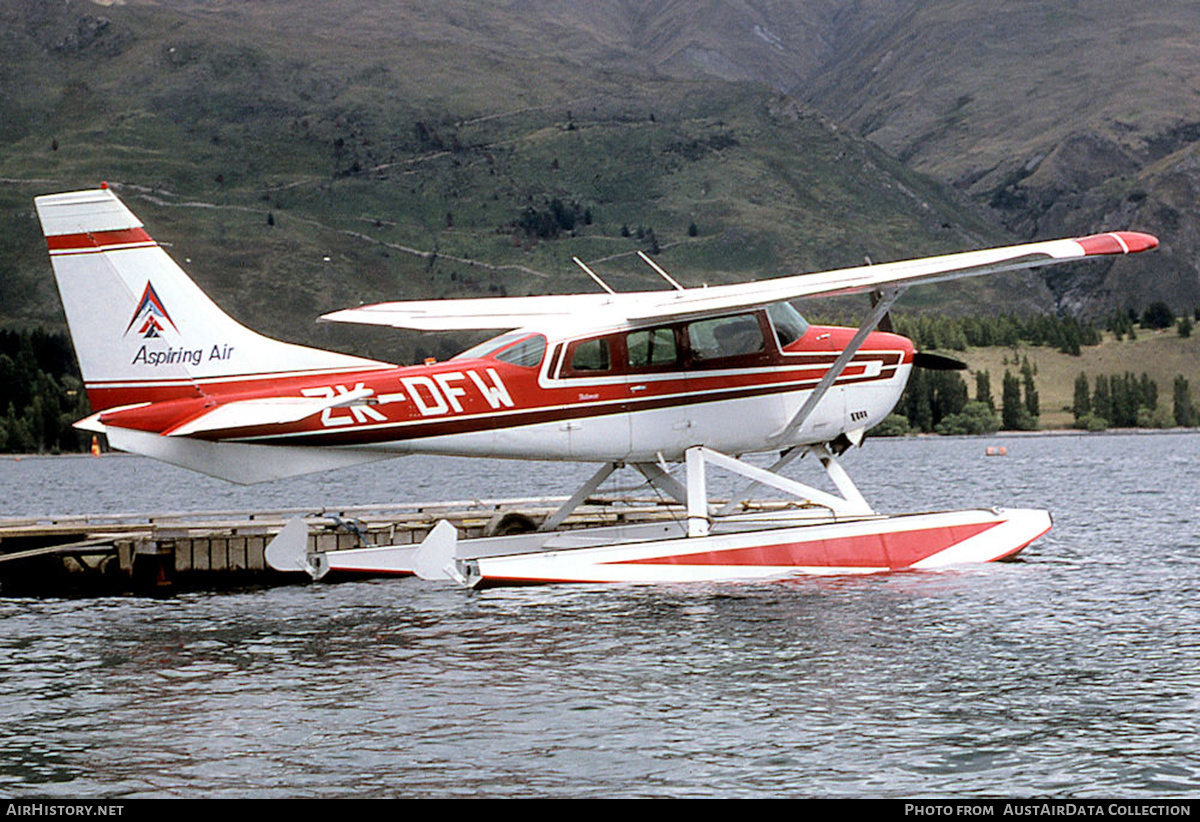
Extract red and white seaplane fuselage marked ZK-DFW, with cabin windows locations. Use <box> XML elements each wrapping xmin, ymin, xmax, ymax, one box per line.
<box><xmin>92</xmin><ymin>307</ymin><xmax>913</xmax><ymax>462</ymax></box>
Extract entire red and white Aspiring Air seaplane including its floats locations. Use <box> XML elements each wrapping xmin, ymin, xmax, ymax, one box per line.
<box><xmin>36</xmin><ymin>185</ymin><xmax>1158</xmax><ymax>586</ymax></box>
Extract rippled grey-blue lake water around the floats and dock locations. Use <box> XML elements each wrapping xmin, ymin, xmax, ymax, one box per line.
<box><xmin>0</xmin><ymin>433</ymin><xmax>1200</xmax><ymax>798</ymax></box>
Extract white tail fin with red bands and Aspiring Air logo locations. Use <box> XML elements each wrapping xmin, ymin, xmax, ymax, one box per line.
<box><xmin>35</xmin><ymin>186</ymin><xmax>389</xmax><ymax>410</ymax></box>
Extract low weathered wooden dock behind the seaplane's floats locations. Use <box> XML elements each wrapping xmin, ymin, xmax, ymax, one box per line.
<box><xmin>0</xmin><ymin>497</ymin><xmax>739</xmax><ymax>596</ymax></box>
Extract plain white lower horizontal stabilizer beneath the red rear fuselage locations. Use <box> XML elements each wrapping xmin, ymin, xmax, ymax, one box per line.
<box><xmin>106</xmin><ymin>426</ymin><xmax>396</xmax><ymax>485</ymax></box>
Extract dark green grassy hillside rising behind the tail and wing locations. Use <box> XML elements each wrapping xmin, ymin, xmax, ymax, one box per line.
<box><xmin>0</xmin><ymin>0</ymin><xmax>1048</xmax><ymax>360</ymax></box>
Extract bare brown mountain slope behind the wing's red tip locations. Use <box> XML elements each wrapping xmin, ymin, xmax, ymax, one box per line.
<box><xmin>805</xmin><ymin>0</ymin><xmax>1200</xmax><ymax>316</ymax></box>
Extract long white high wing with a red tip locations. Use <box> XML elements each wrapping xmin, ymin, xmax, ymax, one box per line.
<box><xmin>322</xmin><ymin>232</ymin><xmax>1158</xmax><ymax>331</ymax></box>
